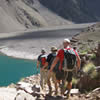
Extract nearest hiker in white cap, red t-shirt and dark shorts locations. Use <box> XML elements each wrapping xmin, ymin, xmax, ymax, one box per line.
<box><xmin>49</xmin><ymin>39</ymin><xmax>80</xmax><ymax>97</ymax></box>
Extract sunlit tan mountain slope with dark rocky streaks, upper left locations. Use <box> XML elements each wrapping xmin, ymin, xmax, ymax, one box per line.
<box><xmin>0</xmin><ymin>0</ymin><xmax>71</xmax><ymax>32</ymax></box>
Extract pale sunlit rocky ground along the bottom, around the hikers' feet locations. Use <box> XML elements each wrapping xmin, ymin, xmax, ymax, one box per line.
<box><xmin>0</xmin><ymin>75</ymin><xmax>100</xmax><ymax>100</ymax></box>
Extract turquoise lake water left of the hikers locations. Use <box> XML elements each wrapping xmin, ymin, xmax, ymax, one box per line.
<box><xmin>0</xmin><ymin>55</ymin><xmax>39</xmax><ymax>86</ymax></box>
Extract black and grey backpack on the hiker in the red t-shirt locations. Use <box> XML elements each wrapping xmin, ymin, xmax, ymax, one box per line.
<box><xmin>63</xmin><ymin>48</ymin><xmax>76</xmax><ymax>71</ymax></box>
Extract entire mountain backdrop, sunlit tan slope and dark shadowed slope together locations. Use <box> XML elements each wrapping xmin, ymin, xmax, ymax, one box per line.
<box><xmin>0</xmin><ymin>0</ymin><xmax>100</xmax><ymax>33</ymax></box>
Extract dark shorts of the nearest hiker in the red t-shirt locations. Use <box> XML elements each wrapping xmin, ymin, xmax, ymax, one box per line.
<box><xmin>56</xmin><ymin>70</ymin><xmax>73</xmax><ymax>82</ymax></box>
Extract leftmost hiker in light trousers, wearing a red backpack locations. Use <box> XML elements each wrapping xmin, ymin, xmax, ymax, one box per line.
<box><xmin>37</xmin><ymin>48</ymin><xmax>47</xmax><ymax>89</ymax></box>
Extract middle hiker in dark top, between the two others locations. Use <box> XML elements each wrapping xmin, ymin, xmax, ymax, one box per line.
<box><xmin>42</xmin><ymin>46</ymin><xmax>58</xmax><ymax>95</ymax></box>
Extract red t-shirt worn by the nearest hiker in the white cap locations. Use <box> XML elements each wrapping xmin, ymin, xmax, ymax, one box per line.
<box><xmin>57</xmin><ymin>48</ymin><xmax>79</xmax><ymax>70</ymax></box>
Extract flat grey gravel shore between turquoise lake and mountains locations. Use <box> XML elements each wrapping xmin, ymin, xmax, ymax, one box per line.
<box><xmin>0</xmin><ymin>24</ymin><xmax>90</xmax><ymax>60</ymax></box>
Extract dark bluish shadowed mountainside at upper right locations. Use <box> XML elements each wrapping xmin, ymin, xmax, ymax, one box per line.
<box><xmin>39</xmin><ymin>0</ymin><xmax>100</xmax><ymax>23</ymax></box>
